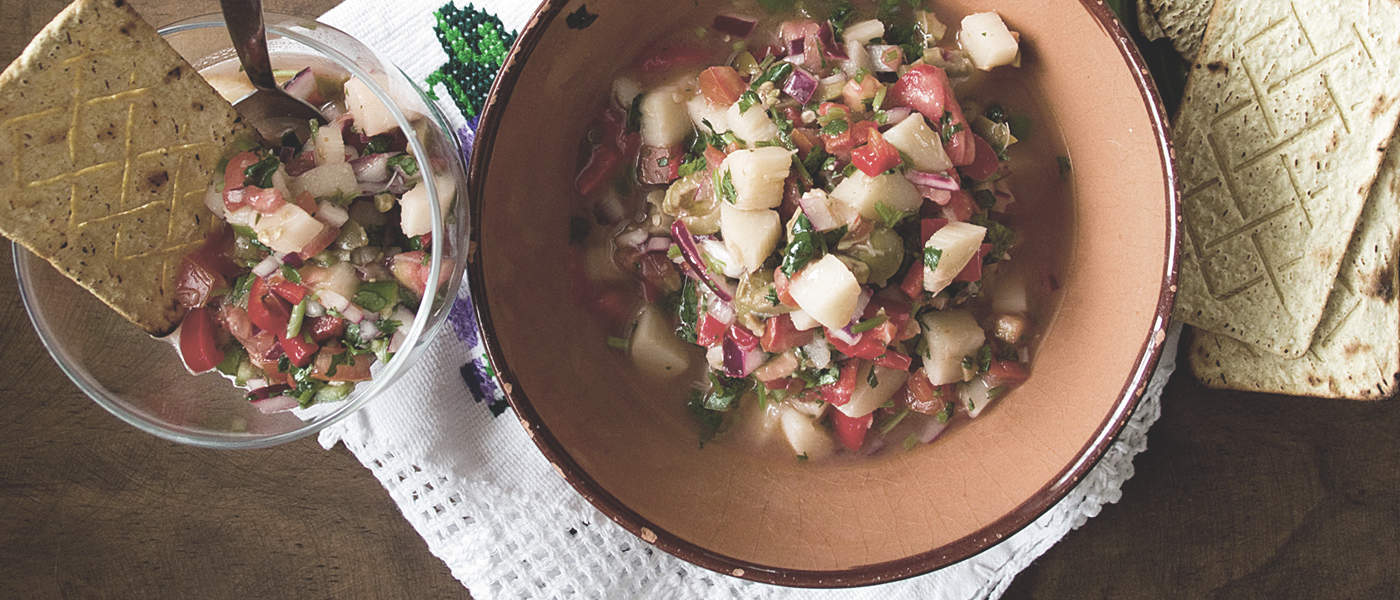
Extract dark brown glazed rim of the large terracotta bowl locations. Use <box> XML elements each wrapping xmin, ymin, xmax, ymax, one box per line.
<box><xmin>468</xmin><ymin>0</ymin><xmax>1180</xmax><ymax>587</ymax></box>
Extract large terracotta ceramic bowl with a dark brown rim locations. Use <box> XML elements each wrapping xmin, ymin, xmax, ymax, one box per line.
<box><xmin>469</xmin><ymin>0</ymin><xmax>1177</xmax><ymax>586</ymax></box>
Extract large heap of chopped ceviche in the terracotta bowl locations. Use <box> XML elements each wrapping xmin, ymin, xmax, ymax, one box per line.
<box><xmin>571</xmin><ymin>0</ymin><xmax>1052</xmax><ymax>460</ymax></box>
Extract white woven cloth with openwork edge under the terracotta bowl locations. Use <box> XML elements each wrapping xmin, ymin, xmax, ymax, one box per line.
<box><xmin>312</xmin><ymin>0</ymin><xmax>1177</xmax><ymax>600</ymax></box>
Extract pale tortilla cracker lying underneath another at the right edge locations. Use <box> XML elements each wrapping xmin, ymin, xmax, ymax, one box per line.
<box><xmin>1190</xmin><ymin>135</ymin><xmax>1400</xmax><ymax>400</ymax></box>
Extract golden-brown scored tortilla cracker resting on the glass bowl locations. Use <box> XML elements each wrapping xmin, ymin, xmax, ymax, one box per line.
<box><xmin>0</xmin><ymin>0</ymin><xmax>246</xmax><ymax>336</ymax></box>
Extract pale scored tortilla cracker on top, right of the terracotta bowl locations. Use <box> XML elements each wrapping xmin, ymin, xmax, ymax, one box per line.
<box><xmin>1173</xmin><ymin>0</ymin><xmax>1400</xmax><ymax>357</ymax></box>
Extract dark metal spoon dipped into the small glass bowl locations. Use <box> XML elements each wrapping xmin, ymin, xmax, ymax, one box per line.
<box><xmin>220</xmin><ymin>0</ymin><xmax>326</xmax><ymax>138</ymax></box>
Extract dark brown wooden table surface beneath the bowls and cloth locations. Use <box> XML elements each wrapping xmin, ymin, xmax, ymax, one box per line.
<box><xmin>0</xmin><ymin>0</ymin><xmax>1400</xmax><ymax>599</ymax></box>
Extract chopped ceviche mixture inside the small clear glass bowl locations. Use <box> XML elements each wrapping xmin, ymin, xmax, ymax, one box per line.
<box><xmin>176</xmin><ymin>67</ymin><xmax>455</xmax><ymax>413</ymax></box>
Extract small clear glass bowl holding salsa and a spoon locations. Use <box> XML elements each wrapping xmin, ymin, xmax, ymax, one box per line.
<box><xmin>14</xmin><ymin>14</ymin><xmax>468</xmax><ymax>449</ymax></box>
